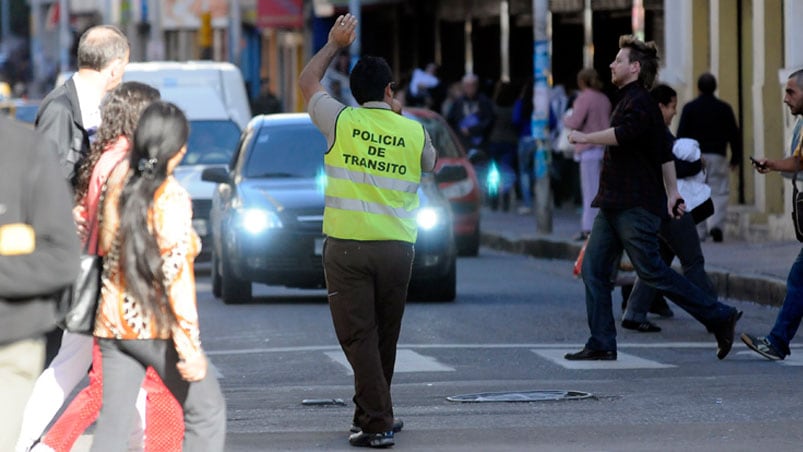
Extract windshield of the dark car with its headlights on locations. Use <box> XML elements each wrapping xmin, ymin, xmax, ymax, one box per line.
<box><xmin>243</xmin><ymin>124</ymin><xmax>326</xmax><ymax>178</ymax></box>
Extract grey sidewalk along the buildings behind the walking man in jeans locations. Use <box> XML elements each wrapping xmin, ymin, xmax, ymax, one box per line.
<box><xmin>480</xmin><ymin>206</ymin><xmax>801</xmax><ymax>306</ymax></box>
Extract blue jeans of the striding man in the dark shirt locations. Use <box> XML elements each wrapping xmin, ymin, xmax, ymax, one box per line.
<box><xmin>582</xmin><ymin>207</ymin><xmax>734</xmax><ymax>351</ymax></box>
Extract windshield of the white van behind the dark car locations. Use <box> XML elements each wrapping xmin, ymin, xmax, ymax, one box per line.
<box><xmin>180</xmin><ymin>120</ymin><xmax>240</xmax><ymax>165</ymax></box>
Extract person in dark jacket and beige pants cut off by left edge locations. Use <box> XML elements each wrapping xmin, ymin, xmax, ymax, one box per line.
<box><xmin>0</xmin><ymin>117</ymin><xmax>80</xmax><ymax>451</ymax></box>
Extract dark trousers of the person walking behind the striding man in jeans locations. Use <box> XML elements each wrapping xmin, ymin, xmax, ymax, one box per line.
<box><xmin>624</xmin><ymin>213</ymin><xmax>717</xmax><ymax>322</ymax></box>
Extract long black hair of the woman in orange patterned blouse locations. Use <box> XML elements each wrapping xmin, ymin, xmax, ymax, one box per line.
<box><xmin>118</xmin><ymin>101</ymin><xmax>190</xmax><ymax>330</ymax></box>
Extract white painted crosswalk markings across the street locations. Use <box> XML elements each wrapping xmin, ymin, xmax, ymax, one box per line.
<box><xmin>220</xmin><ymin>342</ymin><xmax>803</xmax><ymax>375</ymax></box>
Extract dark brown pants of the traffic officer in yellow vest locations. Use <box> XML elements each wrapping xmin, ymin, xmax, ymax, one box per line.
<box><xmin>323</xmin><ymin>237</ymin><xmax>414</xmax><ymax>433</ymax></box>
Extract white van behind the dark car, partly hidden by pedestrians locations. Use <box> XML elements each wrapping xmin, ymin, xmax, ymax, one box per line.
<box><xmin>123</xmin><ymin>61</ymin><xmax>251</xmax><ymax>260</ymax></box>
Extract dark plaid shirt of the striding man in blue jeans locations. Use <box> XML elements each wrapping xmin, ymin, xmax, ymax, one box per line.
<box><xmin>591</xmin><ymin>82</ymin><xmax>673</xmax><ymax>218</ymax></box>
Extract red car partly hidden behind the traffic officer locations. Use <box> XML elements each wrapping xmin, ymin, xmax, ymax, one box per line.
<box><xmin>403</xmin><ymin>108</ymin><xmax>482</xmax><ymax>256</ymax></box>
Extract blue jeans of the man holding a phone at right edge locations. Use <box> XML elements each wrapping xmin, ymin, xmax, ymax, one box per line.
<box><xmin>767</xmin><ymin>249</ymin><xmax>803</xmax><ymax>356</ymax></box>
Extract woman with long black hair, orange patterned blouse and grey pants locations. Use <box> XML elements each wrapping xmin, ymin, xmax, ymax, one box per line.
<box><xmin>92</xmin><ymin>102</ymin><xmax>226</xmax><ymax>451</ymax></box>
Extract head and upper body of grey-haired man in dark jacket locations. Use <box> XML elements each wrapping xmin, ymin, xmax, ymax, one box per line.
<box><xmin>35</xmin><ymin>25</ymin><xmax>129</xmax><ymax>187</ymax></box>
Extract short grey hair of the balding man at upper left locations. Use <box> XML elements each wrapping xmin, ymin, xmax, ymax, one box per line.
<box><xmin>77</xmin><ymin>25</ymin><xmax>129</xmax><ymax>71</ymax></box>
